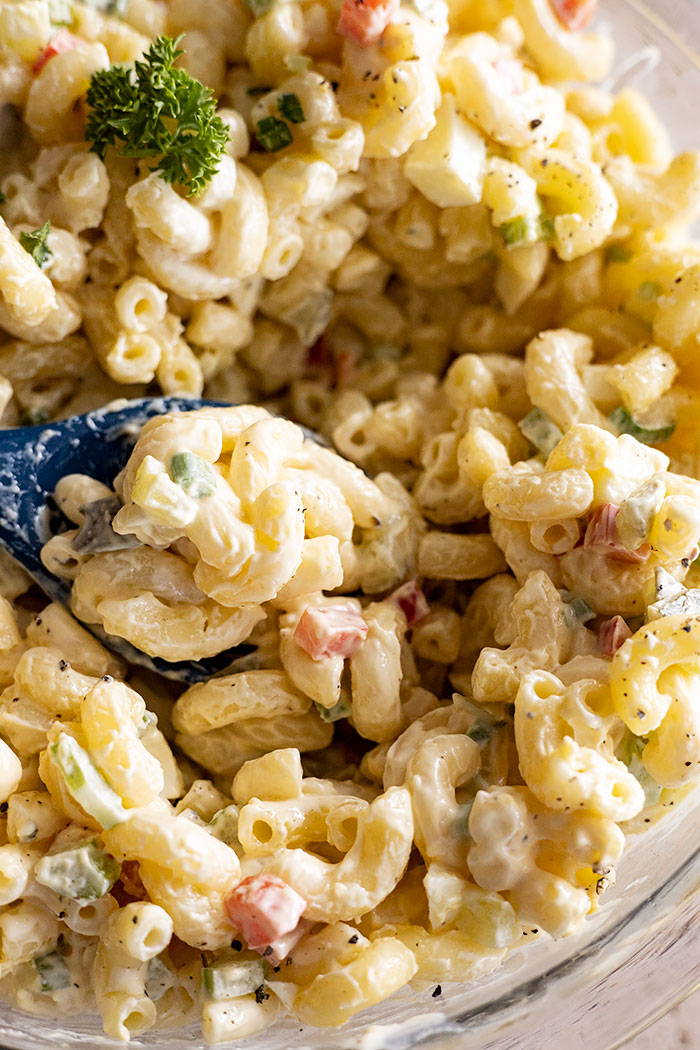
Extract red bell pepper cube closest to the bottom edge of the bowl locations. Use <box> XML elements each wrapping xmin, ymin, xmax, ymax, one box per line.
<box><xmin>226</xmin><ymin>873</ymin><xmax>306</xmax><ymax>956</ymax></box>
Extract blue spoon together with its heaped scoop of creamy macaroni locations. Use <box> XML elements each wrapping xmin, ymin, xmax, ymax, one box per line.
<box><xmin>0</xmin><ymin>398</ymin><xmax>416</xmax><ymax>681</ymax></box>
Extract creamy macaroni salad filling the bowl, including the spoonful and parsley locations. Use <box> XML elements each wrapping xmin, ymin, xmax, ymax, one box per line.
<box><xmin>0</xmin><ymin>0</ymin><xmax>700</xmax><ymax>1043</ymax></box>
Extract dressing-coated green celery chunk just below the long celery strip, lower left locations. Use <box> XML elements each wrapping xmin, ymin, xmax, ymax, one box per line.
<box><xmin>34</xmin><ymin>839</ymin><xmax>122</xmax><ymax>901</ymax></box>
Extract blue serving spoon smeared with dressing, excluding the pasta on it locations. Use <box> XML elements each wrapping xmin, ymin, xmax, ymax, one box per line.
<box><xmin>0</xmin><ymin>397</ymin><xmax>253</xmax><ymax>683</ymax></box>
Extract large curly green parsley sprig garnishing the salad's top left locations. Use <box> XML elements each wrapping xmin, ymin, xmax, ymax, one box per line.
<box><xmin>85</xmin><ymin>37</ymin><xmax>229</xmax><ymax>196</ymax></box>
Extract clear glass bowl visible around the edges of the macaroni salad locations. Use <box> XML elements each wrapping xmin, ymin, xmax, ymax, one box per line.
<box><xmin>0</xmin><ymin>0</ymin><xmax>700</xmax><ymax>1050</ymax></box>
